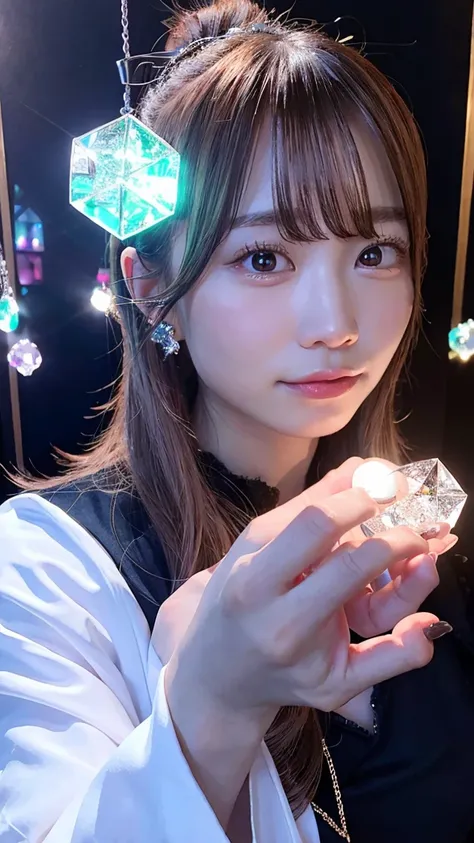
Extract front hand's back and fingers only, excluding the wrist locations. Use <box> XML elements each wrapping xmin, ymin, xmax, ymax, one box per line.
<box><xmin>158</xmin><ymin>462</ymin><xmax>448</xmax><ymax>712</ymax></box>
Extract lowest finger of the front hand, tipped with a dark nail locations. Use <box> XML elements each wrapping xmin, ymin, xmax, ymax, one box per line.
<box><xmin>347</xmin><ymin>612</ymin><xmax>444</xmax><ymax>696</ymax></box>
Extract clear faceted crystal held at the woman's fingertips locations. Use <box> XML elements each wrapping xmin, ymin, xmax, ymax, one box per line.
<box><xmin>362</xmin><ymin>459</ymin><xmax>467</xmax><ymax>535</ymax></box>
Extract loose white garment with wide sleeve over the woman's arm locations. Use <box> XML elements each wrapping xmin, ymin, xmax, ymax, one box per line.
<box><xmin>0</xmin><ymin>495</ymin><xmax>319</xmax><ymax>843</ymax></box>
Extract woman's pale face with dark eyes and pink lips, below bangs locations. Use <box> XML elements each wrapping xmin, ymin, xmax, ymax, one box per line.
<box><xmin>162</xmin><ymin>124</ymin><xmax>413</xmax><ymax>446</ymax></box>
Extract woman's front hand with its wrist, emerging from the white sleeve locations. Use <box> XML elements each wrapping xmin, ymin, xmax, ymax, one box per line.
<box><xmin>153</xmin><ymin>460</ymin><xmax>452</xmax><ymax>828</ymax></box>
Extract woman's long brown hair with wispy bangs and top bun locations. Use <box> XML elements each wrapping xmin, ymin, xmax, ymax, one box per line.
<box><xmin>21</xmin><ymin>0</ymin><xmax>426</xmax><ymax>816</ymax></box>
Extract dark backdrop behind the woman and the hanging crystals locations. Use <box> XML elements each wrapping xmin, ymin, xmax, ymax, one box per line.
<box><xmin>0</xmin><ymin>0</ymin><xmax>474</xmax><ymax>553</ymax></box>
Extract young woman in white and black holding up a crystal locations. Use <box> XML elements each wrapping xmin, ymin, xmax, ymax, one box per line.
<box><xmin>0</xmin><ymin>0</ymin><xmax>474</xmax><ymax>843</ymax></box>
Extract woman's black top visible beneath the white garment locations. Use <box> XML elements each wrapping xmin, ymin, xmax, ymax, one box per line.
<box><xmin>38</xmin><ymin>456</ymin><xmax>474</xmax><ymax>843</ymax></box>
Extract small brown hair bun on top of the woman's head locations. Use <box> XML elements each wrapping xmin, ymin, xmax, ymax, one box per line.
<box><xmin>165</xmin><ymin>0</ymin><xmax>269</xmax><ymax>50</ymax></box>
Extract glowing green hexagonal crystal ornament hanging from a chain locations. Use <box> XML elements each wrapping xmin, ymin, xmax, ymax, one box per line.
<box><xmin>70</xmin><ymin>114</ymin><xmax>180</xmax><ymax>240</ymax></box>
